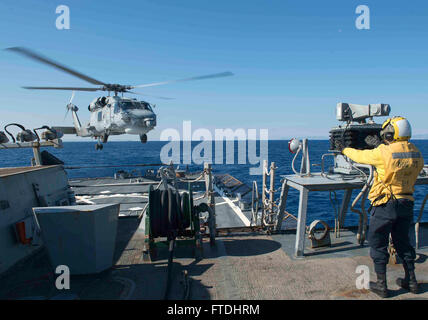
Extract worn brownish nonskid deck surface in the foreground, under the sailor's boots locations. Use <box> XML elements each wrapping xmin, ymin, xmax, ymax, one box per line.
<box><xmin>0</xmin><ymin>219</ymin><xmax>428</xmax><ymax>300</ymax></box>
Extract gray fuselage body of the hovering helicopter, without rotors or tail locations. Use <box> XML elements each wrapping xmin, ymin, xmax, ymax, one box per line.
<box><xmin>86</xmin><ymin>96</ymin><xmax>156</xmax><ymax>136</ymax></box>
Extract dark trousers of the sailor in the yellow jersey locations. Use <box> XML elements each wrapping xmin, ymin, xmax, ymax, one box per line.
<box><xmin>368</xmin><ymin>199</ymin><xmax>416</xmax><ymax>273</ymax></box>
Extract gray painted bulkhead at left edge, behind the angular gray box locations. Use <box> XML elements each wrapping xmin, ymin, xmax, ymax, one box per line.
<box><xmin>0</xmin><ymin>166</ymin><xmax>73</xmax><ymax>274</ymax></box>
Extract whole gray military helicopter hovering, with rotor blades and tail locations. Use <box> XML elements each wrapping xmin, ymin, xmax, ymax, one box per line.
<box><xmin>6</xmin><ymin>47</ymin><xmax>233</xmax><ymax>150</ymax></box>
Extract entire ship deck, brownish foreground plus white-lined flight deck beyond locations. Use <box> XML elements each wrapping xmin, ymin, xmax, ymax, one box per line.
<box><xmin>0</xmin><ymin>178</ymin><xmax>428</xmax><ymax>300</ymax></box>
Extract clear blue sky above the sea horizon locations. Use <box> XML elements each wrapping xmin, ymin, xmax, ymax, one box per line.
<box><xmin>0</xmin><ymin>0</ymin><xmax>428</xmax><ymax>140</ymax></box>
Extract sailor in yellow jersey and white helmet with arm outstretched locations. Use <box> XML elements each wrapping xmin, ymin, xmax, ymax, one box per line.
<box><xmin>339</xmin><ymin>117</ymin><xmax>424</xmax><ymax>298</ymax></box>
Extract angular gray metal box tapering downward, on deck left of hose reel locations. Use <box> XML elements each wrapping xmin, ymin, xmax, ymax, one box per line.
<box><xmin>33</xmin><ymin>204</ymin><xmax>120</xmax><ymax>274</ymax></box>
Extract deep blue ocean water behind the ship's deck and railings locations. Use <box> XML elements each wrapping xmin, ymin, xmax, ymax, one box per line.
<box><xmin>0</xmin><ymin>140</ymin><xmax>428</xmax><ymax>225</ymax></box>
